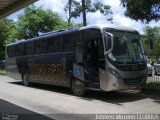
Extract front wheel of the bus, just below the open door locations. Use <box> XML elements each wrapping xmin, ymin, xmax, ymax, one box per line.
<box><xmin>72</xmin><ymin>79</ymin><xmax>86</xmax><ymax>96</ymax></box>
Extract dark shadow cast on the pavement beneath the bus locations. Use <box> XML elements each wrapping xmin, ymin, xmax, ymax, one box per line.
<box><xmin>10</xmin><ymin>82</ymin><xmax>160</xmax><ymax>105</ymax></box>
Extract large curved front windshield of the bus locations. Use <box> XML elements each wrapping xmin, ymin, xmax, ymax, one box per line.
<box><xmin>105</xmin><ymin>31</ymin><xmax>144</xmax><ymax>63</ymax></box>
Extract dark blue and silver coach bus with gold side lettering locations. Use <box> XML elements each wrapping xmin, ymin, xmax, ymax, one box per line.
<box><xmin>6</xmin><ymin>25</ymin><xmax>151</xmax><ymax>96</ymax></box>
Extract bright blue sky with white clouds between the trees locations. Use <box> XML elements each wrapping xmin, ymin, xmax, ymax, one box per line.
<box><xmin>8</xmin><ymin>0</ymin><xmax>160</xmax><ymax>34</ymax></box>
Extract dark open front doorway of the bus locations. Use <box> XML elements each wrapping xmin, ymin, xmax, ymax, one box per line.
<box><xmin>85</xmin><ymin>39</ymin><xmax>99</xmax><ymax>87</ymax></box>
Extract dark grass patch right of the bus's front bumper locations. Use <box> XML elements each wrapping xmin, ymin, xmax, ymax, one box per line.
<box><xmin>141</xmin><ymin>82</ymin><xmax>160</xmax><ymax>95</ymax></box>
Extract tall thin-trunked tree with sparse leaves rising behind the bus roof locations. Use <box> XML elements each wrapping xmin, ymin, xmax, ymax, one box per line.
<box><xmin>64</xmin><ymin>0</ymin><xmax>112</xmax><ymax>26</ymax></box>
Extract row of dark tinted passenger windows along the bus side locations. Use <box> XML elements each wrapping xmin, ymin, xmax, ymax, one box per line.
<box><xmin>7</xmin><ymin>33</ymin><xmax>80</xmax><ymax>57</ymax></box>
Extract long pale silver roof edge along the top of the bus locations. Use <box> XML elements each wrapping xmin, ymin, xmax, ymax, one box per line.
<box><xmin>7</xmin><ymin>24</ymin><xmax>137</xmax><ymax>46</ymax></box>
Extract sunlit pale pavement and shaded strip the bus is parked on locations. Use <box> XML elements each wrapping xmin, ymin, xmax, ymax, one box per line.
<box><xmin>0</xmin><ymin>76</ymin><xmax>160</xmax><ymax>120</ymax></box>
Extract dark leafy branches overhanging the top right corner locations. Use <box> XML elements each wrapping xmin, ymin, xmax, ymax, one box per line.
<box><xmin>121</xmin><ymin>0</ymin><xmax>160</xmax><ymax>23</ymax></box>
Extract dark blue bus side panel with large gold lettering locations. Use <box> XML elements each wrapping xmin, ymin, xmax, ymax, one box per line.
<box><xmin>26</xmin><ymin>53</ymin><xmax>73</xmax><ymax>86</ymax></box>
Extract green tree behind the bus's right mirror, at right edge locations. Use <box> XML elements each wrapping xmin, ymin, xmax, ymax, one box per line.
<box><xmin>142</xmin><ymin>26</ymin><xmax>160</xmax><ymax>59</ymax></box>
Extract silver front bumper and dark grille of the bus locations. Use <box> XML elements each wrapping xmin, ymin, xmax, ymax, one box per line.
<box><xmin>100</xmin><ymin>70</ymin><xmax>147</xmax><ymax>91</ymax></box>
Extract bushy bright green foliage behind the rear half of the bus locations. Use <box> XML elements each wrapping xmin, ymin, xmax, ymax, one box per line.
<box><xmin>0</xmin><ymin>6</ymin><xmax>81</xmax><ymax>59</ymax></box>
